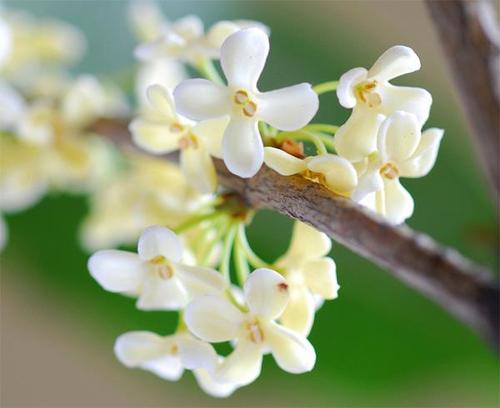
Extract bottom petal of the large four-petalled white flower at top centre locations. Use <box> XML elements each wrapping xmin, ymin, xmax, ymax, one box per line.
<box><xmin>222</xmin><ymin>118</ymin><xmax>264</xmax><ymax>178</ymax></box>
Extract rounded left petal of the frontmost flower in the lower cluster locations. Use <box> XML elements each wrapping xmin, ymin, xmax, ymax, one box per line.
<box><xmin>184</xmin><ymin>295</ymin><xmax>243</xmax><ymax>343</ymax></box>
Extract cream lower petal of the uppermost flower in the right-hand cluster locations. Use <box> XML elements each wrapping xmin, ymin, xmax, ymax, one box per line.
<box><xmin>334</xmin><ymin>105</ymin><xmax>384</xmax><ymax>162</ymax></box>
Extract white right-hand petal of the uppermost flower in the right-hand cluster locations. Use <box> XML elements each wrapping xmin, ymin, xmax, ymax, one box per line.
<box><xmin>377</xmin><ymin>84</ymin><xmax>432</xmax><ymax>126</ymax></box>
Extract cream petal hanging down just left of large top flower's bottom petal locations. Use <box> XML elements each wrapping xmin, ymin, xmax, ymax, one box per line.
<box><xmin>180</xmin><ymin>145</ymin><xmax>217</xmax><ymax>194</ymax></box>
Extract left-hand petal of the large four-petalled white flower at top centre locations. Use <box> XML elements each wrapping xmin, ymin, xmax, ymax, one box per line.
<box><xmin>174</xmin><ymin>78</ymin><xmax>231</xmax><ymax>120</ymax></box>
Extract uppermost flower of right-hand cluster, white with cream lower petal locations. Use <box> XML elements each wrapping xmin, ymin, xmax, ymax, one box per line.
<box><xmin>334</xmin><ymin>45</ymin><xmax>432</xmax><ymax>162</ymax></box>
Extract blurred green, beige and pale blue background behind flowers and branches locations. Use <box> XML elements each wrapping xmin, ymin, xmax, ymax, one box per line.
<box><xmin>0</xmin><ymin>0</ymin><xmax>499</xmax><ymax>408</ymax></box>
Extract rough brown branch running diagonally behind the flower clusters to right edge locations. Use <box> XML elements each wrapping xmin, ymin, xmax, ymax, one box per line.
<box><xmin>93</xmin><ymin>120</ymin><xmax>500</xmax><ymax>348</ymax></box>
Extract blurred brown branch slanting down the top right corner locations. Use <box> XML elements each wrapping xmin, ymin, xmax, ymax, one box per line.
<box><xmin>426</xmin><ymin>0</ymin><xmax>500</xmax><ymax>206</ymax></box>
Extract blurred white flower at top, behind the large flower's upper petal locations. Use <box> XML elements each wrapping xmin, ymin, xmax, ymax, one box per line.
<box><xmin>135</xmin><ymin>15</ymin><xmax>268</xmax><ymax>66</ymax></box>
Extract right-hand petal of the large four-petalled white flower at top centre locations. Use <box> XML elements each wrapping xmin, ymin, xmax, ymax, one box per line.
<box><xmin>257</xmin><ymin>83</ymin><xmax>319</xmax><ymax>131</ymax></box>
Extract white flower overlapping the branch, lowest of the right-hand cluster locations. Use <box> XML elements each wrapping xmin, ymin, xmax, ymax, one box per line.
<box><xmin>352</xmin><ymin>111</ymin><xmax>444</xmax><ymax>224</ymax></box>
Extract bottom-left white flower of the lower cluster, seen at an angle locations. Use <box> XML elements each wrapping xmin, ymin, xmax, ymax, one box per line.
<box><xmin>114</xmin><ymin>331</ymin><xmax>237</xmax><ymax>397</ymax></box>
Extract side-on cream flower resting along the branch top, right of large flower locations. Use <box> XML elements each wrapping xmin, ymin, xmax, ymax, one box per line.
<box><xmin>264</xmin><ymin>147</ymin><xmax>358</xmax><ymax>196</ymax></box>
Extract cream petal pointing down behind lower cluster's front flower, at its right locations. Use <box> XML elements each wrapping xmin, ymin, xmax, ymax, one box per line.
<box><xmin>280</xmin><ymin>287</ymin><xmax>316</xmax><ymax>337</ymax></box>
